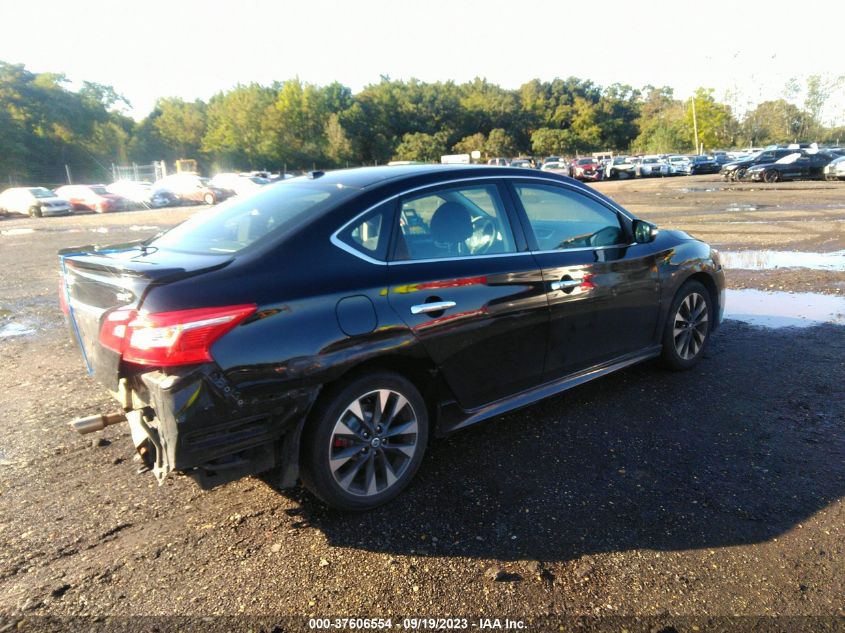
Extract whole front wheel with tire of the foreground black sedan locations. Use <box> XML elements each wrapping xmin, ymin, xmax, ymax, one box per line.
<box><xmin>661</xmin><ymin>280</ymin><xmax>715</xmax><ymax>371</ymax></box>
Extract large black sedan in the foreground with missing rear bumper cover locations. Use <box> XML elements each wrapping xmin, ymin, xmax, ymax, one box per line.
<box><xmin>60</xmin><ymin>166</ymin><xmax>725</xmax><ymax>510</ymax></box>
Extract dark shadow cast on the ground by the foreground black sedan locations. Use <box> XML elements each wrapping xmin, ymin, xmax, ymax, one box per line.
<box><xmin>274</xmin><ymin>321</ymin><xmax>845</xmax><ymax>561</ymax></box>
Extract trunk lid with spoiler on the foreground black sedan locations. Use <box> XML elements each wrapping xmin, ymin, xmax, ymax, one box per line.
<box><xmin>59</xmin><ymin>245</ymin><xmax>232</xmax><ymax>391</ymax></box>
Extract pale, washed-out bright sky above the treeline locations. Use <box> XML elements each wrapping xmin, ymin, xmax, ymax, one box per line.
<box><xmin>0</xmin><ymin>0</ymin><xmax>845</xmax><ymax>124</ymax></box>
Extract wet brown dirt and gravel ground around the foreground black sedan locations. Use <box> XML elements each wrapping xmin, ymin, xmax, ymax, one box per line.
<box><xmin>0</xmin><ymin>177</ymin><xmax>845</xmax><ymax>631</ymax></box>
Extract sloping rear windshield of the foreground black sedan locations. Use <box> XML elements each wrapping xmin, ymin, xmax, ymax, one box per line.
<box><xmin>150</xmin><ymin>181</ymin><xmax>356</xmax><ymax>254</ymax></box>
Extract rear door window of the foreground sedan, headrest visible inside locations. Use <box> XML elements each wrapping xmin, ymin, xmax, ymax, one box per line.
<box><xmin>394</xmin><ymin>185</ymin><xmax>516</xmax><ymax>260</ymax></box>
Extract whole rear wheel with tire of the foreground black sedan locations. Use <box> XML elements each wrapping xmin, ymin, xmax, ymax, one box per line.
<box><xmin>301</xmin><ymin>372</ymin><xmax>428</xmax><ymax>511</ymax></box>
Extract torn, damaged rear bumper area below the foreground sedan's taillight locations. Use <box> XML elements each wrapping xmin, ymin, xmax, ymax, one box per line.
<box><xmin>108</xmin><ymin>366</ymin><xmax>318</xmax><ymax>489</ymax></box>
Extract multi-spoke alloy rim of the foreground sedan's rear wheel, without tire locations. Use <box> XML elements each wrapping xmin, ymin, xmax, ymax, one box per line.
<box><xmin>329</xmin><ymin>389</ymin><xmax>419</xmax><ymax>497</ymax></box>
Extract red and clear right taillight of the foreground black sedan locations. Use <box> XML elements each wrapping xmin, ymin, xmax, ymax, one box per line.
<box><xmin>100</xmin><ymin>304</ymin><xmax>256</xmax><ymax>366</ymax></box>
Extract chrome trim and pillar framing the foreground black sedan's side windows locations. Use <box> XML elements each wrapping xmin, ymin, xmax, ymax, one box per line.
<box><xmin>329</xmin><ymin>174</ymin><xmax>635</xmax><ymax>266</ymax></box>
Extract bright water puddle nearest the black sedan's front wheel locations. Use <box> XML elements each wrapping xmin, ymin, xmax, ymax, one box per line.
<box><xmin>725</xmin><ymin>289</ymin><xmax>845</xmax><ymax>328</ymax></box>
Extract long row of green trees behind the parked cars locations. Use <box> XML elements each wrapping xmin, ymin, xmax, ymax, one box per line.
<box><xmin>0</xmin><ymin>62</ymin><xmax>845</xmax><ymax>182</ymax></box>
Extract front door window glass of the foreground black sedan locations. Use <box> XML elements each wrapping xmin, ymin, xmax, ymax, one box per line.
<box><xmin>516</xmin><ymin>184</ymin><xmax>625</xmax><ymax>251</ymax></box>
